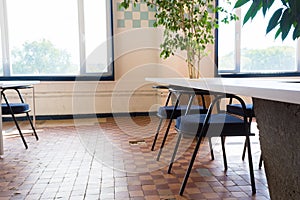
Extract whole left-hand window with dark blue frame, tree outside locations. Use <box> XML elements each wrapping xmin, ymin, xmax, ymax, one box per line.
<box><xmin>0</xmin><ymin>0</ymin><xmax>113</xmax><ymax>80</ymax></box>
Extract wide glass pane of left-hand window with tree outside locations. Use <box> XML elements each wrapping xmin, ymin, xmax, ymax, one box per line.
<box><xmin>7</xmin><ymin>0</ymin><xmax>80</xmax><ymax>76</ymax></box>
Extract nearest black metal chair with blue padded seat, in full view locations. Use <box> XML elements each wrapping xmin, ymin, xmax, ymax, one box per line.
<box><xmin>168</xmin><ymin>94</ymin><xmax>256</xmax><ymax>195</ymax></box>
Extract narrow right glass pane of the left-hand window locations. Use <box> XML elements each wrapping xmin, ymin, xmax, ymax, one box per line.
<box><xmin>84</xmin><ymin>0</ymin><xmax>108</xmax><ymax>73</ymax></box>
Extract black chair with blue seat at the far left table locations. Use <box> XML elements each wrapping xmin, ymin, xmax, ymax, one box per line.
<box><xmin>1</xmin><ymin>86</ymin><xmax>39</xmax><ymax>149</ymax></box>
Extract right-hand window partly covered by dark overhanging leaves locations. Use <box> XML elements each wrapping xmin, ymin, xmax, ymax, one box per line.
<box><xmin>216</xmin><ymin>0</ymin><xmax>300</xmax><ymax>76</ymax></box>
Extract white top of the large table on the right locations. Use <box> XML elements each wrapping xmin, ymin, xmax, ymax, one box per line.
<box><xmin>146</xmin><ymin>78</ymin><xmax>300</xmax><ymax>104</ymax></box>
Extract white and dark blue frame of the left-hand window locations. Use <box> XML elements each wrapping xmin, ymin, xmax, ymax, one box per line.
<box><xmin>0</xmin><ymin>0</ymin><xmax>115</xmax><ymax>81</ymax></box>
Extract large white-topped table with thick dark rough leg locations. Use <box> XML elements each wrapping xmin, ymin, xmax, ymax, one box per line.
<box><xmin>146</xmin><ymin>78</ymin><xmax>300</xmax><ymax>199</ymax></box>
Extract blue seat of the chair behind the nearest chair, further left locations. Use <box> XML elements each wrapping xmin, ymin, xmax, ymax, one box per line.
<box><xmin>157</xmin><ymin>105</ymin><xmax>207</xmax><ymax>119</ymax></box>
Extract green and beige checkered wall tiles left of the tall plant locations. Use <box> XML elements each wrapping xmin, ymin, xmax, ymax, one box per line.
<box><xmin>116</xmin><ymin>2</ymin><xmax>156</xmax><ymax>29</ymax></box>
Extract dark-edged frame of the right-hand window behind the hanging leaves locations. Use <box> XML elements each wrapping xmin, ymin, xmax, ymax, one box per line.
<box><xmin>214</xmin><ymin>0</ymin><xmax>300</xmax><ymax>78</ymax></box>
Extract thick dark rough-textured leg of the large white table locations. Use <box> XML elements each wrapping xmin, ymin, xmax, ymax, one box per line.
<box><xmin>253</xmin><ymin>98</ymin><xmax>300</xmax><ymax>200</ymax></box>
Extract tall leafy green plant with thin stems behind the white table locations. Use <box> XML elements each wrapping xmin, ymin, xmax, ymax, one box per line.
<box><xmin>120</xmin><ymin>0</ymin><xmax>237</xmax><ymax>78</ymax></box>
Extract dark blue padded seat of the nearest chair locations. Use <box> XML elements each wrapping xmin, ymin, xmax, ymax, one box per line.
<box><xmin>175</xmin><ymin>114</ymin><xmax>248</xmax><ymax>137</ymax></box>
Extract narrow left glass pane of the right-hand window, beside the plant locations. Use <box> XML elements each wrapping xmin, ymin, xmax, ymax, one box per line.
<box><xmin>218</xmin><ymin>0</ymin><xmax>235</xmax><ymax>70</ymax></box>
